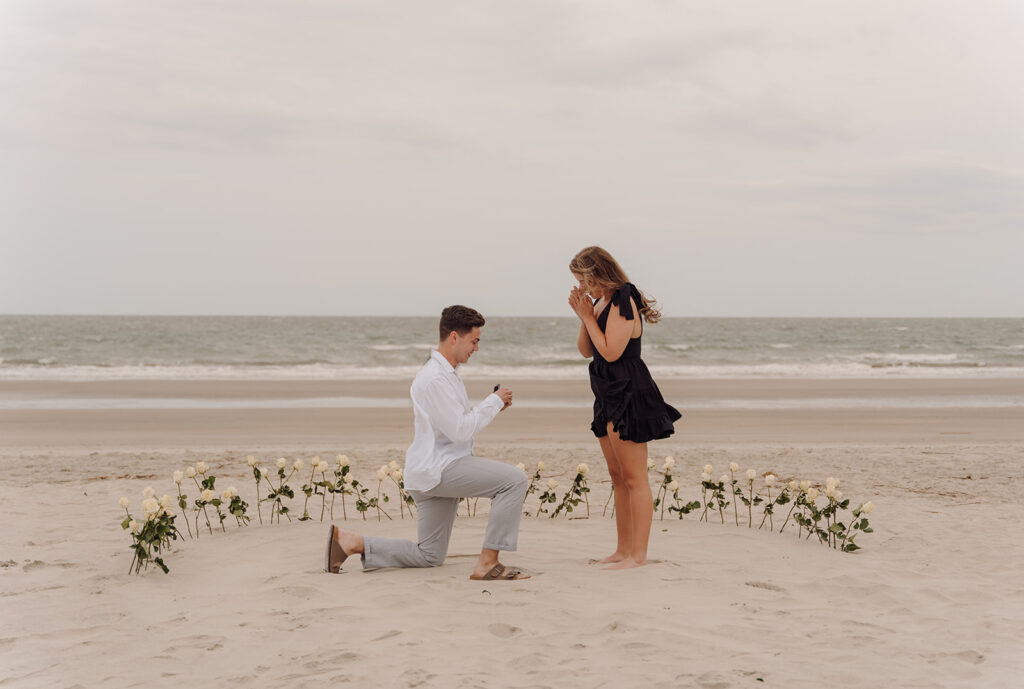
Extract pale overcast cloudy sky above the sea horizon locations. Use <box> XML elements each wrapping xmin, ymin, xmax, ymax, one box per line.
<box><xmin>0</xmin><ymin>0</ymin><xmax>1024</xmax><ymax>316</ymax></box>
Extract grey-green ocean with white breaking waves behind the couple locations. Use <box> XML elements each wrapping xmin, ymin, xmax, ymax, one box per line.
<box><xmin>0</xmin><ymin>315</ymin><xmax>1024</xmax><ymax>381</ymax></box>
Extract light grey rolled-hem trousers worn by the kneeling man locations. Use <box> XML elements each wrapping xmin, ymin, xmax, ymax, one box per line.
<box><xmin>362</xmin><ymin>456</ymin><xmax>528</xmax><ymax>569</ymax></box>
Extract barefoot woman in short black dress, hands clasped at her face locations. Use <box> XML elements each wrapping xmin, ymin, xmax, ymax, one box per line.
<box><xmin>569</xmin><ymin>247</ymin><xmax>682</xmax><ymax>569</ymax></box>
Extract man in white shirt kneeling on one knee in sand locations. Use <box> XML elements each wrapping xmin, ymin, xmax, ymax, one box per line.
<box><xmin>324</xmin><ymin>306</ymin><xmax>529</xmax><ymax>580</ymax></box>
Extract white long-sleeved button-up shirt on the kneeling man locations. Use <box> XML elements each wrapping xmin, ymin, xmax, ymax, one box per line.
<box><xmin>404</xmin><ymin>349</ymin><xmax>505</xmax><ymax>490</ymax></box>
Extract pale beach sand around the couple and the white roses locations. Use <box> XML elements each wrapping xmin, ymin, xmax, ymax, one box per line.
<box><xmin>0</xmin><ymin>380</ymin><xmax>1024</xmax><ymax>689</ymax></box>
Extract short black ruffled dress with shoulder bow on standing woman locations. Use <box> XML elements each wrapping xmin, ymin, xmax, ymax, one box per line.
<box><xmin>590</xmin><ymin>283</ymin><xmax>683</xmax><ymax>442</ymax></box>
